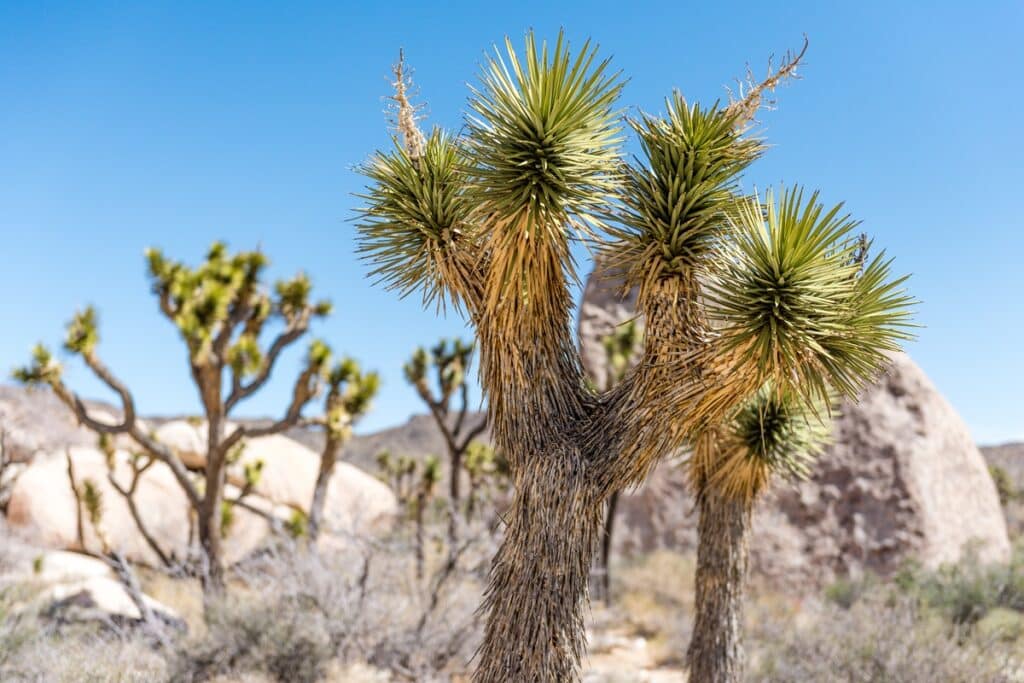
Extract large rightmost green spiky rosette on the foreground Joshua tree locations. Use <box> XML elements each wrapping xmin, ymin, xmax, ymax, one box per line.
<box><xmin>707</xmin><ymin>188</ymin><xmax>914</xmax><ymax>403</ymax></box>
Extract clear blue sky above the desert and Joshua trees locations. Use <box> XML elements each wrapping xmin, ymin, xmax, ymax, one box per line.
<box><xmin>0</xmin><ymin>0</ymin><xmax>1024</xmax><ymax>442</ymax></box>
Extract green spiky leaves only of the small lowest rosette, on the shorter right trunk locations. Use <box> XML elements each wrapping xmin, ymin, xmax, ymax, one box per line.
<box><xmin>733</xmin><ymin>384</ymin><xmax>831</xmax><ymax>478</ymax></box>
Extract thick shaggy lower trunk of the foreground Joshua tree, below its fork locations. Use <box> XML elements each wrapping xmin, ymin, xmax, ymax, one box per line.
<box><xmin>473</xmin><ymin>453</ymin><xmax>603</xmax><ymax>683</ymax></box>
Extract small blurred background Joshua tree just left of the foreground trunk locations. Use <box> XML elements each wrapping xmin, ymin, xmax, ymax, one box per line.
<box><xmin>404</xmin><ymin>339</ymin><xmax>487</xmax><ymax>548</ymax></box>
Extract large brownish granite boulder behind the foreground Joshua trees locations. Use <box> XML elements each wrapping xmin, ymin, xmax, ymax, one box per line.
<box><xmin>580</xmin><ymin>270</ymin><xmax>1010</xmax><ymax>587</ymax></box>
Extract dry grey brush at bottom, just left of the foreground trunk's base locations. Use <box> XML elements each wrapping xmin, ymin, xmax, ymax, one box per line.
<box><xmin>172</xmin><ymin>537</ymin><xmax>489</xmax><ymax>682</ymax></box>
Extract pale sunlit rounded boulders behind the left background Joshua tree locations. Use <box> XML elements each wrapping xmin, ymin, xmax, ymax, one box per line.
<box><xmin>7</xmin><ymin>432</ymin><xmax>397</xmax><ymax>565</ymax></box>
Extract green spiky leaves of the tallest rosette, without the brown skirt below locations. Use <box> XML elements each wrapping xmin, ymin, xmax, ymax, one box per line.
<box><xmin>466</xmin><ymin>32</ymin><xmax>623</xmax><ymax>235</ymax></box>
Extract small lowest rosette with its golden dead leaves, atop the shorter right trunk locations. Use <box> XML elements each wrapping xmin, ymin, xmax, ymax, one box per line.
<box><xmin>689</xmin><ymin>383</ymin><xmax>830</xmax><ymax>503</ymax></box>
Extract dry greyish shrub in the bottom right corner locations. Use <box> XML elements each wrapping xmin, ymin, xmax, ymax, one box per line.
<box><xmin>751</xmin><ymin>597</ymin><xmax>1019</xmax><ymax>683</ymax></box>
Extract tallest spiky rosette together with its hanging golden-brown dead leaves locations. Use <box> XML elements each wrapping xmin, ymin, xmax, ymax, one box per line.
<box><xmin>466</xmin><ymin>33</ymin><xmax>622</xmax><ymax>338</ymax></box>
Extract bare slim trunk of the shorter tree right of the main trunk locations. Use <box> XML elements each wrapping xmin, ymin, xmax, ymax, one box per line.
<box><xmin>686</xmin><ymin>492</ymin><xmax>751</xmax><ymax>683</ymax></box>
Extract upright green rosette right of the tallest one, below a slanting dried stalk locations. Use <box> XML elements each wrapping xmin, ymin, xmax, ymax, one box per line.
<box><xmin>603</xmin><ymin>92</ymin><xmax>763</xmax><ymax>291</ymax></box>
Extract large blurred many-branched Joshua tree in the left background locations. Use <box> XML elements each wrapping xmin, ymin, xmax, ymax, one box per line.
<box><xmin>14</xmin><ymin>243</ymin><xmax>344</xmax><ymax>590</ymax></box>
